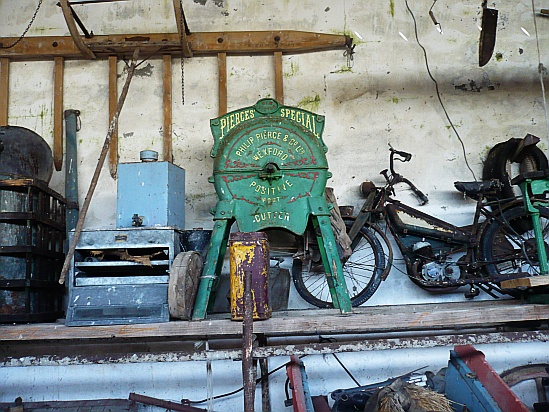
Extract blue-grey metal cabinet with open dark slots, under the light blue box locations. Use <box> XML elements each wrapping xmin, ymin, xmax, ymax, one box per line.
<box><xmin>66</xmin><ymin>227</ymin><xmax>184</xmax><ymax>326</ymax></box>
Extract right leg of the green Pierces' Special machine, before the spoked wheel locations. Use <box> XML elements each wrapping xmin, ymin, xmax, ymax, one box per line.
<box><xmin>311</xmin><ymin>215</ymin><xmax>352</xmax><ymax>313</ymax></box>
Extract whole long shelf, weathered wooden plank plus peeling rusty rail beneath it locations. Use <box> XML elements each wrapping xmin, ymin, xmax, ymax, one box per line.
<box><xmin>0</xmin><ymin>300</ymin><xmax>549</xmax><ymax>367</ymax></box>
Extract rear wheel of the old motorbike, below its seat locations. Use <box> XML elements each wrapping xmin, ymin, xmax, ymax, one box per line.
<box><xmin>481</xmin><ymin>206</ymin><xmax>549</xmax><ymax>277</ymax></box>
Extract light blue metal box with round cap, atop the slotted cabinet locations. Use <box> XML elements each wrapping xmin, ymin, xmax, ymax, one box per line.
<box><xmin>116</xmin><ymin>161</ymin><xmax>185</xmax><ymax>230</ymax></box>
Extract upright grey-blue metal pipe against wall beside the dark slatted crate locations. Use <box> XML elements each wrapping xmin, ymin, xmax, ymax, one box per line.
<box><xmin>65</xmin><ymin>109</ymin><xmax>80</xmax><ymax>238</ymax></box>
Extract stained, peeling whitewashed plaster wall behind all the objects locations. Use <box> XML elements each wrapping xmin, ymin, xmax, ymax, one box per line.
<box><xmin>0</xmin><ymin>0</ymin><xmax>549</xmax><ymax>411</ymax></box>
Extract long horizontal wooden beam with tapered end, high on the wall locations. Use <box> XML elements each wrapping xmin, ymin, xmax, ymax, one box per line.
<box><xmin>0</xmin><ymin>30</ymin><xmax>352</xmax><ymax>61</ymax></box>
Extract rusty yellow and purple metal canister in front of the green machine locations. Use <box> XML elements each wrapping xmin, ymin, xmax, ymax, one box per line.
<box><xmin>229</xmin><ymin>232</ymin><xmax>272</xmax><ymax>320</ymax></box>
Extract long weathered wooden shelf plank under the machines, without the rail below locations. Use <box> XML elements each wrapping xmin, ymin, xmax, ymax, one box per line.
<box><xmin>0</xmin><ymin>300</ymin><xmax>549</xmax><ymax>342</ymax></box>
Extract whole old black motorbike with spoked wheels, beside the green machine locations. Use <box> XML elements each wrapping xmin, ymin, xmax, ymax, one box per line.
<box><xmin>292</xmin><ymin>143</ymin><xmax>549</xmax><ymax>308</ymax></box>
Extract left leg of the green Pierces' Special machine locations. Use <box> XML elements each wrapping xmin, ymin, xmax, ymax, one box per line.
<box><xmin>193</xmin><ymin>220</ymin><xmax>232</xmax><ymax>320</ymax></box>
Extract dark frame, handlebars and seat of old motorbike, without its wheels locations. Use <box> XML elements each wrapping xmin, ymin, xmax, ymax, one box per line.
<box><xmin>349</xmin><ymin>148</ymin><xmax>523</xmax><ymax>294</ymax></box>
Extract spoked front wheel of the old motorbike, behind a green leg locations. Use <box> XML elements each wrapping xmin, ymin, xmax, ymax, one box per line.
<box><xmin>292</xmin><ymin>220</ymin><xmax>385</xmax><ymax>308</ymax></box>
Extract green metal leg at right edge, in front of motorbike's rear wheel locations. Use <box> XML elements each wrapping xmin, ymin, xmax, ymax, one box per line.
<box><xmin>519</xmin><ymin>178</ymin><xmax>549</xmax><ymax>275</ymax></box>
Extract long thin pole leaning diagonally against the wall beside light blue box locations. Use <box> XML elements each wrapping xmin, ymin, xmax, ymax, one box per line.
<box><xmin>59</xmin><ymin>47</ymin><xmax>139</xmax><ymax>284</ymax></box>
